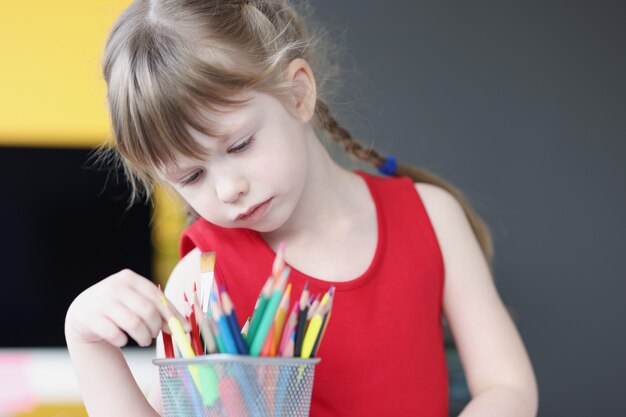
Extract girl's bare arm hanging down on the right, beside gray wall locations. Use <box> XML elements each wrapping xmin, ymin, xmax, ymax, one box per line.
<box><xmin>416</xmin><ymin>183</ymin><xmax>538</xmax><ymax>417</ymax></box>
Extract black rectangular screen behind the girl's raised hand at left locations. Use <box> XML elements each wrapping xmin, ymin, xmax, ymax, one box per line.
<box><xmin>0</xmin><ymin>148</ymin><xmax>151</xmax><ymax>347</ymax></box>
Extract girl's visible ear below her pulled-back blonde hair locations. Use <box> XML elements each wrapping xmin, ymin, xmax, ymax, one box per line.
<box><xmin>285</xmin><ymin>58</ymin><xmax>317</xmax><ymax>123</ymax></box>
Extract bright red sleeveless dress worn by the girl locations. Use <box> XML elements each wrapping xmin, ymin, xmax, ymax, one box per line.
<box><xmin>181</xmin><ymin>171</ymin><xmax>448</xmax><ymax>417</ymax></box>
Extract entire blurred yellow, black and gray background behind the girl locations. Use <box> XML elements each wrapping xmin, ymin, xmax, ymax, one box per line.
<box><xmin>0</xmin><ymin>0</ymin><xmax>626</xmax><ymax>417</ymax></box>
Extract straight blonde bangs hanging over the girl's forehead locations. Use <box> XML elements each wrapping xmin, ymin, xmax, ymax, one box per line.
<box><xmin>109</xmin><ymin>24</ymin><xmax>258</xmax><ymax>178</ymax></box>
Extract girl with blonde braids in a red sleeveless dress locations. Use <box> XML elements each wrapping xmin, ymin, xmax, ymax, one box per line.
<box><xmin>66</xmin><ymin>0</ymin><xmax>537</xmax><ymax>417</ymax></box>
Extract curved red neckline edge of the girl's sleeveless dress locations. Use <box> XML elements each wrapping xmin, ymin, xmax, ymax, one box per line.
<box><xmin>246</xmin><ymin>170</ymin><xmax>386</xmax><ymax>291</ymax></box>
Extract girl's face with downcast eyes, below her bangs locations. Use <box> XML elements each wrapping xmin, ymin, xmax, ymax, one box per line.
<box><xmin>162</xmin><ymin>92</ymin><xmax>308</xmax><ymax>232</ymax></box>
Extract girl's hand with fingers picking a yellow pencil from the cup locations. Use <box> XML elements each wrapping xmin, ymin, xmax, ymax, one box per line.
<box><xmin>65</xmin><ymin>269</ymin><xmax>191</xmax><ymax>347</ymax></box>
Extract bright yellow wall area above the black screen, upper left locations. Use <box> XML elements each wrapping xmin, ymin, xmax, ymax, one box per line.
<box><xmin>0</xmin><ymin>0</ymin><xmax>129</xmax><ymax>147</ymax></box>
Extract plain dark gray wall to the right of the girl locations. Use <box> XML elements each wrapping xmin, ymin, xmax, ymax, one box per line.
<box><xmin>312</xmin><ymin>0</ymin><xmax>626</xmax><ymax>417</ymax></box>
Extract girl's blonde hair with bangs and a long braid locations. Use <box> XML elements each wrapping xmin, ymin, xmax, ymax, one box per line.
<box><xmin>103</xmin><ymin>0</ymin><xmax>493</xmax><ymax>260</ymax></box>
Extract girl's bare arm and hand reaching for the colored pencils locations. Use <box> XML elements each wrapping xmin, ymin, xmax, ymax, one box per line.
<box><xmin>65</xmin><ymin>249</ymin><xmax>199</xmax><ymax>417</ymax></box>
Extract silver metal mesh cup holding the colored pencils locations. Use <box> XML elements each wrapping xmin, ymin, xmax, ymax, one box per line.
<box><xmin>152</xmin><ymin>354</ymin><xmax>320</xmax><ymax>417</ymax></box>
